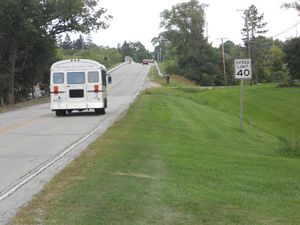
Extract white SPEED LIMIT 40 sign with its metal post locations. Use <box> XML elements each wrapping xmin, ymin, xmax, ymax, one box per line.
<box><xmin>234</xmin><ymin>59</ymin><xmax>252</xmax><ymax>130</ymax></box>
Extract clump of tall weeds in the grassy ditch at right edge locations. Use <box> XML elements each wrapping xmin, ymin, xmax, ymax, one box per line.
<box><xmin>279</xmin><ymin>136</ymin><xmax>300</xmax><ymax>158</ymax></box>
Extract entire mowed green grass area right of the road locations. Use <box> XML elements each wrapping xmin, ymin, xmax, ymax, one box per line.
<box><xmin>12</xmin><ymin>73</ymin><xmax>300</xmax><ymax>225</ymax></box>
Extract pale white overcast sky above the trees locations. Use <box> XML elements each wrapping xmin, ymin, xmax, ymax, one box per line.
<box><xmin>92</xmin><ymin>0</ymin><xmax>300</xmax><ymax>51</ymax></box>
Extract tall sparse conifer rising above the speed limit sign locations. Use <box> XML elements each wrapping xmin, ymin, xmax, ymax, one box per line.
<box><xmin>242</xmin><ymin>5</ymin><xmax>267</xmax><ymax>83</ymax></box>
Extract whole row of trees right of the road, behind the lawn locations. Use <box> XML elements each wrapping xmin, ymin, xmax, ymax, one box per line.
<box><xmin>152</xmin><ymin>0</ymin><xmax>300</xmax><ymax>86</ymax></box>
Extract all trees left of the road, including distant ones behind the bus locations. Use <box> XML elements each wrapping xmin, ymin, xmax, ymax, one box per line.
<box><xmin>0</xmin><ymin>0</ymin><xmax>151</xmax><ymax>105</ymax></box>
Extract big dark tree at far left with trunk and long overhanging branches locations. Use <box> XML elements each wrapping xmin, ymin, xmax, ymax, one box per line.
<box><xmin>0</xmin><ymin>0</ymin><xmax>111</xmax><ymax>103</ymax></box>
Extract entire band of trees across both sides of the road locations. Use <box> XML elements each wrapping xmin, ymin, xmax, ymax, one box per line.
<box><xmin>0</xmin><ymin>0</ymin><xmax>300</xmax><ymax>104</ymax></box>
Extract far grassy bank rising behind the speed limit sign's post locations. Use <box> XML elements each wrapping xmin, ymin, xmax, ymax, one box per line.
<box><xmin>188</xmin><ymin>84</ymin><xmax>300</xmax><ymax>136</ymax></box>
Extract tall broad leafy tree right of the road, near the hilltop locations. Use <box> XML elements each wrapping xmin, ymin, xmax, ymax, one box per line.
<box><xmin>154</xmin><ymin>0</ymin><xmax>223</xmax><ymax>85</ymax></box>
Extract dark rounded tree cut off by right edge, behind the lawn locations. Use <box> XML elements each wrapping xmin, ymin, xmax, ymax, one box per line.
<box><xmin>284</xmin><ymin>38</ymin><xmax>300</xmax><ymax>79</ymax></box>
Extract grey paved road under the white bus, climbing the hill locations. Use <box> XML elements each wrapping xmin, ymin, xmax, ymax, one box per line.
<box><xmin>0</xmin><ymin>64</ymin><xmax>150</xmax><ymax>224</ymax></box>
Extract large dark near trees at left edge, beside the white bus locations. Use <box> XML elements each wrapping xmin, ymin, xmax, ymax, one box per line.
<box><xmin>0</xmin><ymin>0</ymin><xmax>112</xmax><ymax>104</ymax></box>
